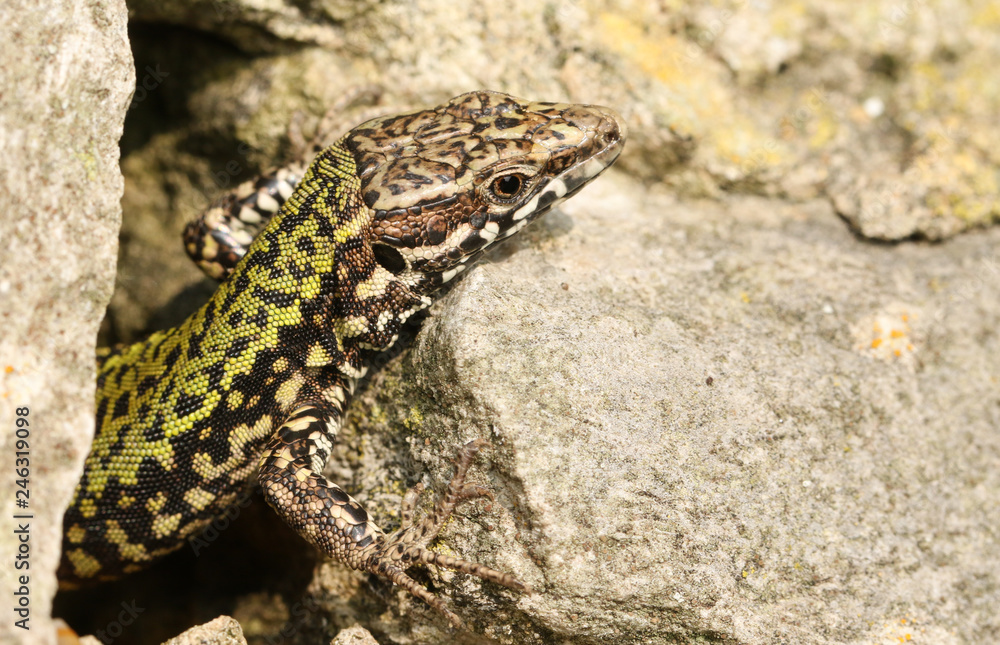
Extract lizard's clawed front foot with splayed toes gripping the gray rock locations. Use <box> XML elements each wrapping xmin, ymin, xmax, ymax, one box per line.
<box><xmin>363</xmin><ymin>439</ymin><xmax>531</xmax><ymax>627</ymax></box>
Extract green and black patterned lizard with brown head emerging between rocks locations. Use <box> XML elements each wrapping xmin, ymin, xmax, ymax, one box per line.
<box><xmin>58</xmin><ymin>91</ymin><xmax>626</xmax><ymax>626</ymax></box>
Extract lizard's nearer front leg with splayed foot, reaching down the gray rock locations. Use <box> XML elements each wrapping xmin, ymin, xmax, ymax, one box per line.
<box><xmin>259</xmin><ymin>405</ymin><xmax>528</xmax><ymax>626</ymax></box>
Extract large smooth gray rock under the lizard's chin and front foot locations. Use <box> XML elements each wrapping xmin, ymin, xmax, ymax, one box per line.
<box><xmin>324</xmin><ymin>175</ymin><xmax>1000</xmax><ymax>644</ymax></box>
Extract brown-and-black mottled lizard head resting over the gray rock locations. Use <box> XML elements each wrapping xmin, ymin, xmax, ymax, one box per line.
<box><xmin>344</xmin><ymin>91</ymin><xmax>626</xmax><ymax>296</ymax></box>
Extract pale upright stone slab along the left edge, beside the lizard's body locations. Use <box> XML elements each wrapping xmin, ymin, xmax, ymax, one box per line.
<box><xmin>0</xmin><ymin>1</ymin><xmax>133</xmax><ymax>643</ymax></box>
